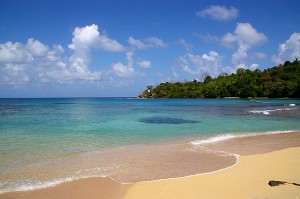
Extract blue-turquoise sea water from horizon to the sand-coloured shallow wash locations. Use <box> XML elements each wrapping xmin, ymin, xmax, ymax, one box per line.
<box><xmin>0</xmin><ymin>98</ymin><xmax>300</xmax><ymax>193</ymax></box>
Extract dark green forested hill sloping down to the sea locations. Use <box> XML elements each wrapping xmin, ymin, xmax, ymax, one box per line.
<box><xmin>139</xmin><ymin>59</ymin><xmax>300</xmax><ymax>98</ymax></box>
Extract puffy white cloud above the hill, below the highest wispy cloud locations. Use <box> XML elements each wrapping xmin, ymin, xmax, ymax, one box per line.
<box><xmin>222</xmin><ymin>23</ymin><xmax>267</xmax><ymax>65</ymax></box>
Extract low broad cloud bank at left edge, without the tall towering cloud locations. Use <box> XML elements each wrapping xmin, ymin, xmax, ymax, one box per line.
<box><xmin>0</xmin><ymin>39</ymin><xmax>102</xmax><ymax>87</ymax></box>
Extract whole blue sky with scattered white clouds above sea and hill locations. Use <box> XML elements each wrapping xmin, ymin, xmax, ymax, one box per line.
<box><xmin>0</xmin><ymin>0</ymin><xmax>300</xmax><ymax>98</ymax></box>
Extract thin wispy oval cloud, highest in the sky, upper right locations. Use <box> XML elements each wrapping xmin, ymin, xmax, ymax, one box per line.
<box><xmin>196</xmin><ymin>5</ymin><xmax>239</xmax><ymax>21</ymax></box>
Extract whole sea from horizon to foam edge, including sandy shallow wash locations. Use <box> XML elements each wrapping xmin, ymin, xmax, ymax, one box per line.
<box><xmin>0</xmin><ymin>98</ymin><xmax>300</xmax><ymax>193</ymax></box>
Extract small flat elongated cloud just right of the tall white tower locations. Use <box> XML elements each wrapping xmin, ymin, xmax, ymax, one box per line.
<box><xmin>128</xmin><ymin>36</ymin><xmax>167</xmax><ymax>49</ymax></box>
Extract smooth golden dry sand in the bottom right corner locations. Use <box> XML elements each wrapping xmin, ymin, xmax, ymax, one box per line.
<box><xmin>125</xmin><ymin>148</ymin><xmax>300</xmax><ymax>199</ymax></box>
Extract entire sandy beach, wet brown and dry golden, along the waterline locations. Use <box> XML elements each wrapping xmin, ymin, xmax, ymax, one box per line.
<box><xmin>0</xmin><ymin>133</ymin><xmax>300</xmax><ymax>199</ymax></box>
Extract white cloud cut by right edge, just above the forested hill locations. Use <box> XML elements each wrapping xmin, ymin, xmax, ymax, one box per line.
<box><xmin>272</xmin><ymin>32</ymin><xmax>300</xmax><ymax>64</ymax></box>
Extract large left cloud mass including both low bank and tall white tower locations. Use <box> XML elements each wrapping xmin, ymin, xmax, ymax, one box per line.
<box><xmin>0</xmin><ymin>24</ymin><xmax>130</xmax><ymax>87</ymax></box>
